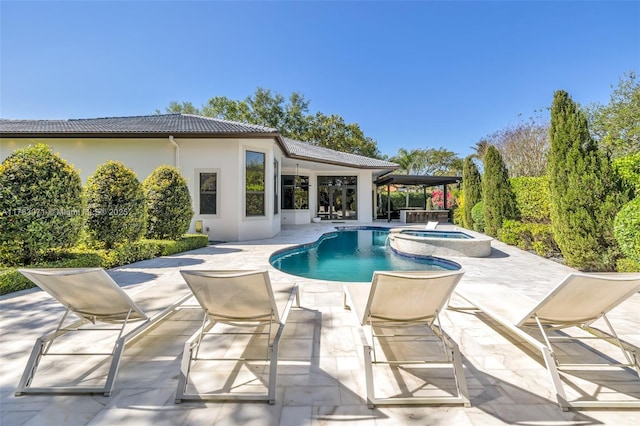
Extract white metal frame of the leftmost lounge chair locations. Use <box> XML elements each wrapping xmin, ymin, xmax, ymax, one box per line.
<box><xmin>15</xmin><ymin>268</ymin><xmax>191</xmax><ymax>396</ymax></box>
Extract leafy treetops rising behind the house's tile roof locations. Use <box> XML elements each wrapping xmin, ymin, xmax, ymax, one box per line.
<box><xmin>156</xmin><ymin>87</ymin><xmax>381</xmax><ymax>158</ymax></box>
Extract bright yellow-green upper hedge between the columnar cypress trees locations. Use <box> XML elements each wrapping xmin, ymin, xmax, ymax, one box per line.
<box><xmin>510</xmin><ymin>176</ymin><xmax>551</xmax><ymax>223</ymax></box>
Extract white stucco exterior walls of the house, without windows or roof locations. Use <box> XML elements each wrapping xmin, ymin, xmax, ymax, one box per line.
<box><xmin>0</xmin><ymin>138</ymin><xmax>373</xmax><ymax>241</ymax></box>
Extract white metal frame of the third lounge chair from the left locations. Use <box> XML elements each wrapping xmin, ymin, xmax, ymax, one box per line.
<box><xmin>344</xmin><ymin>271</ymin><xmax>471</xmax><ymax>408</ymax></box>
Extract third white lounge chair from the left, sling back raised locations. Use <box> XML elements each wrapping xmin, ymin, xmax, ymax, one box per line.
<box><xmin>344</xmin><ymin>271</ymin><xmax>470</xmax><ymax>408</ymax></box>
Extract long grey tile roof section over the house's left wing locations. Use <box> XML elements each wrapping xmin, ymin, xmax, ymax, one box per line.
<box><xmin>0</xmin><ymin>114</ymin><xmax>278</xmax><ymax>136</ymax></box>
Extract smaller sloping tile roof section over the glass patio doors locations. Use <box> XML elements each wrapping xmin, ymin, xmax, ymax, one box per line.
<box><xmin>282</xmin><ymin>137</ymin><xmax>398</xmax><ymax>169</ymax></box>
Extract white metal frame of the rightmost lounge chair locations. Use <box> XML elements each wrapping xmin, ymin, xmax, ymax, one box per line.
<box><xmin>450</xmin><ymin>273</ymin><xmax>640</xmax><ymax>411</ymax></box>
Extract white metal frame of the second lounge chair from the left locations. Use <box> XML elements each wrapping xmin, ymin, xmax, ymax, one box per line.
<box><xmin>175</xmin><ymin>270</ymin><xmax>300</xmax><ymax>405</ymax></box>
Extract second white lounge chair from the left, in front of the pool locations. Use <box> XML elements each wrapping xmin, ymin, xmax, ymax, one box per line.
<box><xmin>176</xmin><ymin>270</ymin><xmax>300</xmax><ymax>404</ymax></box>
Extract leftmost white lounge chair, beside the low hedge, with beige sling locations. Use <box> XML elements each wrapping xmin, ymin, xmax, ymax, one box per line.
<box><xmin>15</xmin><ymin>268</ymin><xmax>190</xmax><ymax>396</ymax></box>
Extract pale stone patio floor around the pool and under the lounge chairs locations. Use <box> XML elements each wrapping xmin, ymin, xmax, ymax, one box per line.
<box><xmin>0</xmin><ymin>222</ymin><xmax>640</xmax><ymax>426</ymax></box>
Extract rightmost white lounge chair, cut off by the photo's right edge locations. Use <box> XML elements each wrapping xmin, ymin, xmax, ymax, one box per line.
<box><xmin>456</xmin><ymin>273</ymin><xmax>640</xmax><ymax>411</ymax></box>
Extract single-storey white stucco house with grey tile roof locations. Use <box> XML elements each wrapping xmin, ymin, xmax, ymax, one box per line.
<box><xmin>0</xmin><ymin>114</ymin><xmax>398</xmax><ymax>241</ymax></box>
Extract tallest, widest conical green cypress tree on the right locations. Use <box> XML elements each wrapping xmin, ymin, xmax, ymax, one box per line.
<box><xmin>548</xmin><ymin>90</ymin><xmax>628</xmax><ymax>271</ymax></box>
